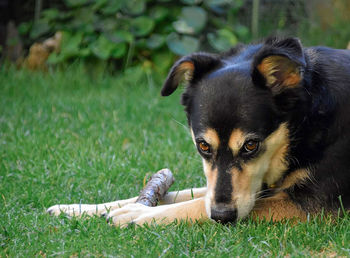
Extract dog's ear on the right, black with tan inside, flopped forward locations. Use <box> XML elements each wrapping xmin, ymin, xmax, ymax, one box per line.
<box><xmin>252</xmin><ymin>38</ymin><xmax>306</xmax><ymax>95</ymax></box>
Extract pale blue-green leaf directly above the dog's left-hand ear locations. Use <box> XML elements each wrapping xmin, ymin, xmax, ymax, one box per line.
<box><xmin>167</xmin><ymin>33</ymin><xmax>199</xmax><ymax>55</ymax></box>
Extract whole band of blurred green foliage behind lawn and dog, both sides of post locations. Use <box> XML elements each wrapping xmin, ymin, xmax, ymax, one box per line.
<box><xmin>17</xmin><ymin>0</ymin><xmax>350</xmax><ymax>78</ymax></box>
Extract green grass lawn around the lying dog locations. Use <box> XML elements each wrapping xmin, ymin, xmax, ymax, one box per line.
<box><xmin>0</xmin><ymin>68</ymin><xmax>350</xmax><ymax>257</ymax></box>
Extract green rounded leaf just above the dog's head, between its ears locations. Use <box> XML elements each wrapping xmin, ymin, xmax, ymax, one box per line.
<box><xmin>207</xmin><ymin>29</ymin><xmax>238</xmax><ymax>51</ymax></box>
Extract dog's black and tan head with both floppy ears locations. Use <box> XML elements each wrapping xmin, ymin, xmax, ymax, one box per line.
<box><xmin>162</xmin><ymin>38</ymin><xmax>305</xmax><ymax>222</ymax></box>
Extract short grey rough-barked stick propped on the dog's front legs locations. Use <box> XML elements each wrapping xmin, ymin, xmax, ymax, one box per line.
<box><xmin>136</xmin><ymin>168</ymin><xmax>175</xmax><ymax>207</ymax></box>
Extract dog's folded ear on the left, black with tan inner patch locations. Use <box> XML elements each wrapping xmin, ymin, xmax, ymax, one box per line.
<box><xmin>161</xmin><ymin>53</ymin><xmax>221</xmax><ymax>96</ymax></box>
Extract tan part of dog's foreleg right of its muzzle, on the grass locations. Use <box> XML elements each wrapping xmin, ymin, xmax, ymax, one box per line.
<box><xmin>250</xmin><ymin>192</ymin><xmax>307</xmax><ymax>221</ymax></box>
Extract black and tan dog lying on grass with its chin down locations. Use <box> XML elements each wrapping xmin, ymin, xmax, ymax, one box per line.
<box><xmin>48</xmin><ymin>37</ymin><xmax>350</xmax><ymax>225</ymax></box>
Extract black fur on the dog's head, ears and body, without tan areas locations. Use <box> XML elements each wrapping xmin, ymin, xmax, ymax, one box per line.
<box><xmin>162</xmin><ymin>38</ymin><xmax>350</xmax><ymax>216</ymax></box>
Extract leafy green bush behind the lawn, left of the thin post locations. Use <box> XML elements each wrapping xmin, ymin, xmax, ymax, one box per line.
<box><xmin>20</xmin><ymin>0</ymin><xmax>249</xmax><ymax>74</ymax></box>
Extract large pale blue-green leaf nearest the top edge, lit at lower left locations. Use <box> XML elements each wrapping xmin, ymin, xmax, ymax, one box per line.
<box><xmin>173</xmin><ymin>7</ymin><xmax>207</xmax><ymax>34</ymax></box>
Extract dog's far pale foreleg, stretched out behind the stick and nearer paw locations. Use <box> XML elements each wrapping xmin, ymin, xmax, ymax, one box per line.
<box><xmin>47</xmin><ymin>187</ymin><xmax>206</xmax><ymax>216</ymax></box>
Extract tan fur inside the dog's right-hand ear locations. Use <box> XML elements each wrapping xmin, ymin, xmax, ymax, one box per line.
<box><xmin>257</xmin><ymin>56</ymin><xmax>302</xmax><ymax>88</ymax></box>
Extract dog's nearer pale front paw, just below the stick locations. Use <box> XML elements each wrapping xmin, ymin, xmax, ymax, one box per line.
<box><xmin>106</xmin><ymin>203</ymin><xmax>162</xmax><ymax>227</ymax></box>
